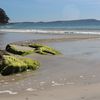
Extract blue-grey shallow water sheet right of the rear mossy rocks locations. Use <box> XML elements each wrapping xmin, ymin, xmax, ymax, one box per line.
<box><xmin>49</xmin><ymin>39</ymin><xmax>100</xmax><ymax>60</ymax></box>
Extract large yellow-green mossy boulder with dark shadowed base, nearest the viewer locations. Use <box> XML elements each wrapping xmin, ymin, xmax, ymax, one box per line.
<box><xmin>0</xmin><ymin>55</ymin><xmax>40</xmax><ymax>76</ymax></box>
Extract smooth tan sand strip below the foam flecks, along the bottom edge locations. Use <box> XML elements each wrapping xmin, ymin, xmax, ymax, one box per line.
<box><xmin>1</xmin><ymin>84</ymin><xmax>100</xmax><ymax>100</ymax></box>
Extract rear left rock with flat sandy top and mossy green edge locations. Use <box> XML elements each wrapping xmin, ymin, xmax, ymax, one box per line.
<box><xmin>6</xmin><ymin>44</ymin><xmax>34</xmax><ymax>56</ymax></box>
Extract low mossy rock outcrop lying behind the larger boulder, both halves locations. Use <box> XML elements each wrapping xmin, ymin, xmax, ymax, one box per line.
<box><xmin>6</xmin><ymin>43</ymin><xmax>61</xmax><ymax>56</ymax></box>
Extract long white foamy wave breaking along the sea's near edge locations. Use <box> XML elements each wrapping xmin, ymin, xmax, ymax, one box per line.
<box><xmin>0</xmin><ymin>29</ymin><xmax>100</xmax><ymax>34</ymax></box>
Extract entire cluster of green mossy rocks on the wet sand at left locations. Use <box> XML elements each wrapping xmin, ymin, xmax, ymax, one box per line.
<box><xmin>0</xmin><ymin>43</ymin><xmax>61</xmax><ymax>76</ymax></box>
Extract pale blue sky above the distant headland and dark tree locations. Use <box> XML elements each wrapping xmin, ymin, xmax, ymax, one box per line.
<box><xmin>0</xmin><ymin>0</ymin><xmax>100</xmax><ymax>22</ymax></box>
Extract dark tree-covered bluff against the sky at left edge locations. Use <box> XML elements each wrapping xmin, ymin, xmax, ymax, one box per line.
<box><xmin>0</xmin><ymin>8</ymin><xmax>9</xmax><ymax>24</ymax></box>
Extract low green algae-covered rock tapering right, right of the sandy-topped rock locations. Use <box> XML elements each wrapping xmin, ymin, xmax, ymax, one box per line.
<box><xmin>29</xmin><ymin>43</ymin><xmax>61</xmax><ymax>55</ymax></box>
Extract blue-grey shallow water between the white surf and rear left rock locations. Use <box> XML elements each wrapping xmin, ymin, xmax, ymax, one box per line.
<box><xmin>0</xmin><ymin>33</ymin><xmax>61</xmax><ymax>49</ymax></box>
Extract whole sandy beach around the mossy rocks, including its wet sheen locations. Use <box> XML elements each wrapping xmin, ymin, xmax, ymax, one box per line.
<box><xmin>0</xmin><ymin>34</ymin><xmax>100</xmax><ymax>100</ymax></box>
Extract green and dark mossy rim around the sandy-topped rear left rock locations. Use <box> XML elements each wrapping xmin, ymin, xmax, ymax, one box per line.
<box><xmin>6</xmin><ymin>44</ymin><xmax>34</xmax><ymax>56</ymax></box>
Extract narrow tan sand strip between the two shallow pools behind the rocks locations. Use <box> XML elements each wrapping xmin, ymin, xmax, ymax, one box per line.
<box><xmin>11</xmin><ymin>34</ymin><xmax>100</xmax><ymax>45</ymax></box>
